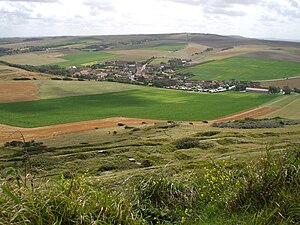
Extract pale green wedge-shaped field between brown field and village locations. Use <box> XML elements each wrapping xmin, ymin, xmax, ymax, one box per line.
<box><xmin>35</xmin><ymin>80</ymin><xmax>143</xmax><ymax>99</ymax></box>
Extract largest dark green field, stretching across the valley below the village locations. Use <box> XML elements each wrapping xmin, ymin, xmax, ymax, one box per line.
<box><xmin>0</xmin><ymin>88</ymin><xmax>275</xmax><ymax>127</ymax></box>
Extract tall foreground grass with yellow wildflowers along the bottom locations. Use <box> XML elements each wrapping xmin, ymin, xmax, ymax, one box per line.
<box><xmin>0</xmin><ymin>146</ymin><xmax>300</xmax><ymax>225</ymax></box>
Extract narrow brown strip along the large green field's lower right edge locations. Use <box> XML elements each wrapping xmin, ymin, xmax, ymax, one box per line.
<box><xmin>210</xmin><ymin>107</ymin><xmax>275</xmax><ymax>123</ymax></box>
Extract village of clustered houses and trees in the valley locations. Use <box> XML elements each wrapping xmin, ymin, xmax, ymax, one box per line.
<box><xmin>68</xmin><ymin>57</ymin><xmax>262</xmax><ymax>93</ymax></box>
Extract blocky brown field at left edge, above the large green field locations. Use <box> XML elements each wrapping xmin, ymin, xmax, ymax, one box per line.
<box><xmin>0</xmin><ymin>81</ymin><xmax>38</xmax><ymax>103</ymax></box>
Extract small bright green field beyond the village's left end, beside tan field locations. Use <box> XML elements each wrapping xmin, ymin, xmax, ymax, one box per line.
<box><xmin>55</xmin><ymin>52</ymin><xmax>120</xmax><ymax>67</ymax></box>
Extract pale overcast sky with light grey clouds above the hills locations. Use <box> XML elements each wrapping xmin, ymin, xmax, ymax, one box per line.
<box><xmin>0</xmin><ymin>0</ymin><xmax>300</xmax><ymax>40</ymax></box>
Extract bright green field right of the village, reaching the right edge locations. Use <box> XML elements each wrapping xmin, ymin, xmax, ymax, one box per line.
<box><xmin>179</xmin><ymin>57</ymin><xmax>300</xmax><ymax>80</ymax></box>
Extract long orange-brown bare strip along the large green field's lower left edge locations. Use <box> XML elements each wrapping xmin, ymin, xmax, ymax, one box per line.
<box><xmin>0</xmin><ymin>117</ymin><xmax>159</xmax><ymax>143</ymax></box>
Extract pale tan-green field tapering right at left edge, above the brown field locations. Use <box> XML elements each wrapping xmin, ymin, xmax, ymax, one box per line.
<box><xmin>0</xmin><ymin>64</ymin><xmax>60</xmax><ymax>81</ymax></box>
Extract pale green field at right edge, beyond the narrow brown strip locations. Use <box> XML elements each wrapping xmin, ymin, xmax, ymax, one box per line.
<box><xmin>261</xmin><ymin>94</ymin><xmax>300</xmax><ymax>120</ymax></box>
